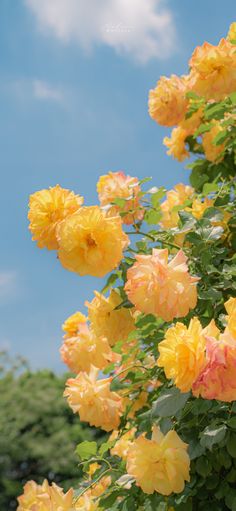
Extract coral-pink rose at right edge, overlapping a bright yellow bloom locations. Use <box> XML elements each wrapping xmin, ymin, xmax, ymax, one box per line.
<box><xmin>192</xmin><ymin>334</ymin><xmax>236</xmax><ymax>402</ymax></box>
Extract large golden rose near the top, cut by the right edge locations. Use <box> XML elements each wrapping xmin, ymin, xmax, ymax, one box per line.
<box><xmin>189</xmin><ymin>39</ymin><xmax>236</xmax><ymax>101</ymax></box>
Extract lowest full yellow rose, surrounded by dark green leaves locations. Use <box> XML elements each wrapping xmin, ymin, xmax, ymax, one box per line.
<box><xmin>127</xmin><ymin>427</ymin><xmax>190</xmax><ymax>495</ymax></box>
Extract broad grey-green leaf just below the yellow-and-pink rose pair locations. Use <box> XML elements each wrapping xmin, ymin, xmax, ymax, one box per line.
<box><xmin>152</xmin><ymin>387</ymin><xmax>190</xmax><ymax>417</ymax></box>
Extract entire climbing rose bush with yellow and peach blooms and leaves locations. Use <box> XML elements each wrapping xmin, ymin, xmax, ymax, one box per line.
<box><xmin>18</xmin><ymin>23</ymin><xmax>236</xmax><ymax>511</ymax></box>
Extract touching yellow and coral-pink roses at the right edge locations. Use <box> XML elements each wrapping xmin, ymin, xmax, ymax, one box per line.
<box><xmin>157</xmin><ymin>298</ymin><xmax>236</xmax><ymax>401</ymax></box>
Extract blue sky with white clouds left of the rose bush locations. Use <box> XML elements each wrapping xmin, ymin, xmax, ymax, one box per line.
<box><xmin>0</xmin><ymin>0</ymin><xmax>235</xmax><ymax>370</ymax></box>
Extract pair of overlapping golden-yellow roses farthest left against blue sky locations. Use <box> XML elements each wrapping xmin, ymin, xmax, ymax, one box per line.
<box><xmin>28</xmin><ymin>185</ymin><xmax>129</xmax><ymax>277</ymax></box>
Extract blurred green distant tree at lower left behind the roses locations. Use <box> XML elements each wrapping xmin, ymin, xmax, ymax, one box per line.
<box><xmin>0</xmin><ymin>356</ymin><xmax>99</xmax><ymax>511</ymax></box>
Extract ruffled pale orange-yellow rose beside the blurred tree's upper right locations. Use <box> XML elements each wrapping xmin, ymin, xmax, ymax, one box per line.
<box><xmin>64</xmin><ymin>366</ymin><xmax>122</xmax><ymax>431</ymax></box>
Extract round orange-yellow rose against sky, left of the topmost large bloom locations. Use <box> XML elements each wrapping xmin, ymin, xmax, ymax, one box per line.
<box><xmin>149</xmin><ymin>75</ymin><xmax>188</xmax><ymax>126</ymax></box>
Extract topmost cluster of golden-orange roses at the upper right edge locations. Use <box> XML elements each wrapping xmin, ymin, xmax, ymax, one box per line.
<box><xmin>149</xmin><ymin>23</ymin><xmax>236</xmax><ymax>162</ymax></box>
